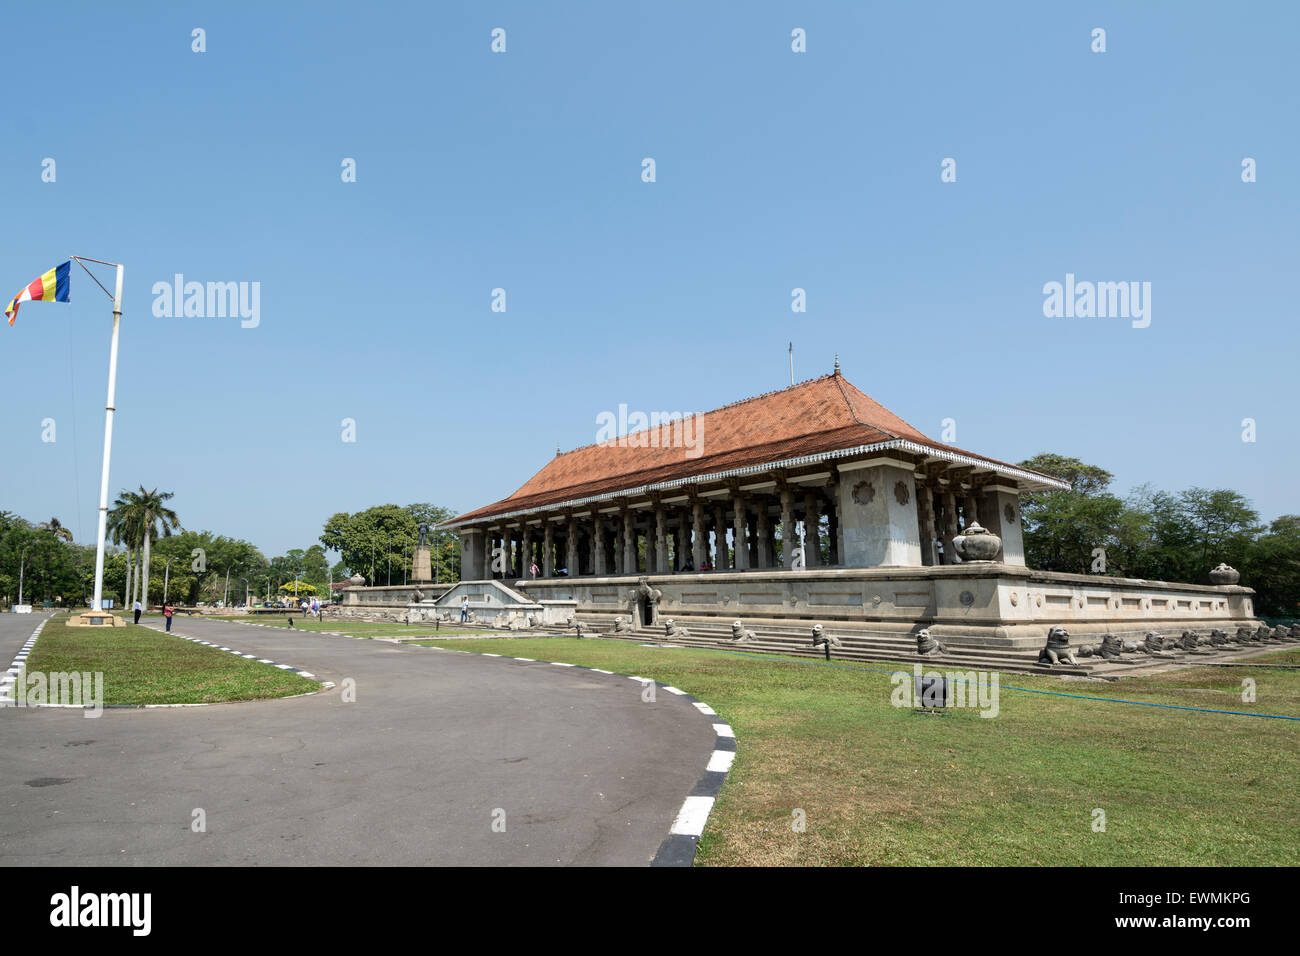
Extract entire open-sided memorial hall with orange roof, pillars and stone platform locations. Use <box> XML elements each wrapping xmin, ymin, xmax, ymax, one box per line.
<box><xmin>390</xmin><ymin>362</ymin><xmax>1260</xmax><ymax>663</ymax></box>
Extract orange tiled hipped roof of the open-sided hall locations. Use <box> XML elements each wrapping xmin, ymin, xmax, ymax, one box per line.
<box><xmin>447</xmin><ymin>373</ymin><xmax>1052</xmax><ymax>524</ymax></box>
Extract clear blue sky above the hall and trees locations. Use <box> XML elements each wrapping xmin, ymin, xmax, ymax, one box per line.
<box><xmin>0</xmin><ymin>3</ymin><xmax>1300</xmax><ymax>555</ymax></box>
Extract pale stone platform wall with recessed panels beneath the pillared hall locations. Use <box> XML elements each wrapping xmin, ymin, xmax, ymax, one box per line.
<box><xmin>507</xmin><ymin>561</ymin><xmax>1258</xmax><ymax>649</ymax></box>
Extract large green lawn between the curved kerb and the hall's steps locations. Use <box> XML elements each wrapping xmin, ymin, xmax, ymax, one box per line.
<box><xmin>410</xmin><ymin>637</ymin><xmax>1300</xmax><ymax>866</ymax></box>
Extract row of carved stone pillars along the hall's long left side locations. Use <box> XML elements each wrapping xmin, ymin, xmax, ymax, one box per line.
<box><xmin>462</xmin><ymin>485</ymin><xmax>842</xmax><ymax>579</ymax></box>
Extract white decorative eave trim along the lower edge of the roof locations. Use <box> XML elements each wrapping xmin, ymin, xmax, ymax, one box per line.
<box><xmin>436</xmin><ymin>438</ymin><xmax>1070</xmax><ymax>529</ymax></box>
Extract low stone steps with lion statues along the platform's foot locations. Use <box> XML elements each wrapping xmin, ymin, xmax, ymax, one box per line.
<box><xmin>577</xmin><ymin>613</ymin><xmax>1300</xmax><ymax>680</ymax></box>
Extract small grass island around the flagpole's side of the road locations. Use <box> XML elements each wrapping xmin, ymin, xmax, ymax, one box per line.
<box><xmin>18</xmin><ymin>615</ymin><xmax>320</xmax><ymax>704</ymax></box>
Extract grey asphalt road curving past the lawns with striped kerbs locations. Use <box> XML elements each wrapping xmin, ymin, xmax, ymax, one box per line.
<box><xmin>0</xmin><ymin>614</ymin><xmax>714</xmax><ymax>866</ymax></box>
